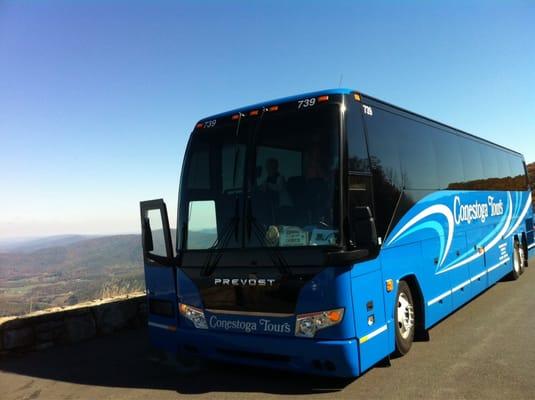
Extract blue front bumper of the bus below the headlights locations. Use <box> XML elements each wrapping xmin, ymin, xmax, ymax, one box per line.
<box><xmin>176</xmin><ymin>329</ymin><xmax>359</xmax><ymax>377</ymax></box>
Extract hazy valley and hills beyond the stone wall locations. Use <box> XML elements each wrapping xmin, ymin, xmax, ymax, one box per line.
<box><xmin>0</xmin><ymin>235</ymin><xmax>145</xmax><ymax>317</ymax></box>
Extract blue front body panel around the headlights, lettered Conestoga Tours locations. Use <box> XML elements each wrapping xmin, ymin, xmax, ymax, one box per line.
<box><xmin>174</xmin><ymin>267</ymin><xmax>362</xmax><ymax>377</ymax></box>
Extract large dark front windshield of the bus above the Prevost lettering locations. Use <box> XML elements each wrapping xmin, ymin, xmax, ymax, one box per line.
<box><xmin>179</xmin><ymin>104</ymin><xmax>340</xmax><ymax>250</ymax></box>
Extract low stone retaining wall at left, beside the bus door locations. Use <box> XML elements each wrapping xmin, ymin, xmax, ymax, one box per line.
<box><xmin>0</xmin><ymin>294</ymin><xmax>147</xmax><ymax>355</ymax></box>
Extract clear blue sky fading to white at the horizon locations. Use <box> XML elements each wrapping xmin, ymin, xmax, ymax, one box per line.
<box><xmin>0</xmin><ymin>0</ymin><xmax>535</xmax><ymax>238</ymax></box>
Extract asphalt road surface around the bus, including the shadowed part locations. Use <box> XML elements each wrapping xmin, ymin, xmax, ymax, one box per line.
<box><xmin>0</xmin><ymin>259</ymin><xmax>535</xmax><ymax>400</ymax></box>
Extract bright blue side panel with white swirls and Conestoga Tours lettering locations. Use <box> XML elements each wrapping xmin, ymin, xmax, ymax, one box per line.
<box><xmin>380</xmin><ymin>191</ymin><xmax>532</xmax><ymax>327</ymax></box>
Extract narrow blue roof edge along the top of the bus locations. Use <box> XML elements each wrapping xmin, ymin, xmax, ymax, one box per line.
<box><xmin>198</xmin><ymin>88</ymin><xmax>523</xmax><ymax>158</ymax></box>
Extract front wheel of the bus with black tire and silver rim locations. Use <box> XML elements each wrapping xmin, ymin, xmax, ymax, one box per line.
<box><xmin>394</xmin><ymin>281</ymin><xmax>416</xmax><ymax>356</ymax></box>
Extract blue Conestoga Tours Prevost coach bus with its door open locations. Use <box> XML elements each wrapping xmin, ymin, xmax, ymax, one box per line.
<box><xmin>141</xmin><ymin>89</ymin><xmax>535</xmax><ymax>377</ymax></box>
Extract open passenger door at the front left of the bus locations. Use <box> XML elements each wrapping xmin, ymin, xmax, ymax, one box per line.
<box><xmin>140</xmin><ymin>199</ymin><xmax>178</xmax><ymax>353</ymax></box>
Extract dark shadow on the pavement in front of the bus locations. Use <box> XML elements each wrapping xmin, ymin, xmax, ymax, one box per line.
<box><xmin>0</xmin><ymin>329</ymin><xmax>352</xmax><ymax>394</ymax></box>
